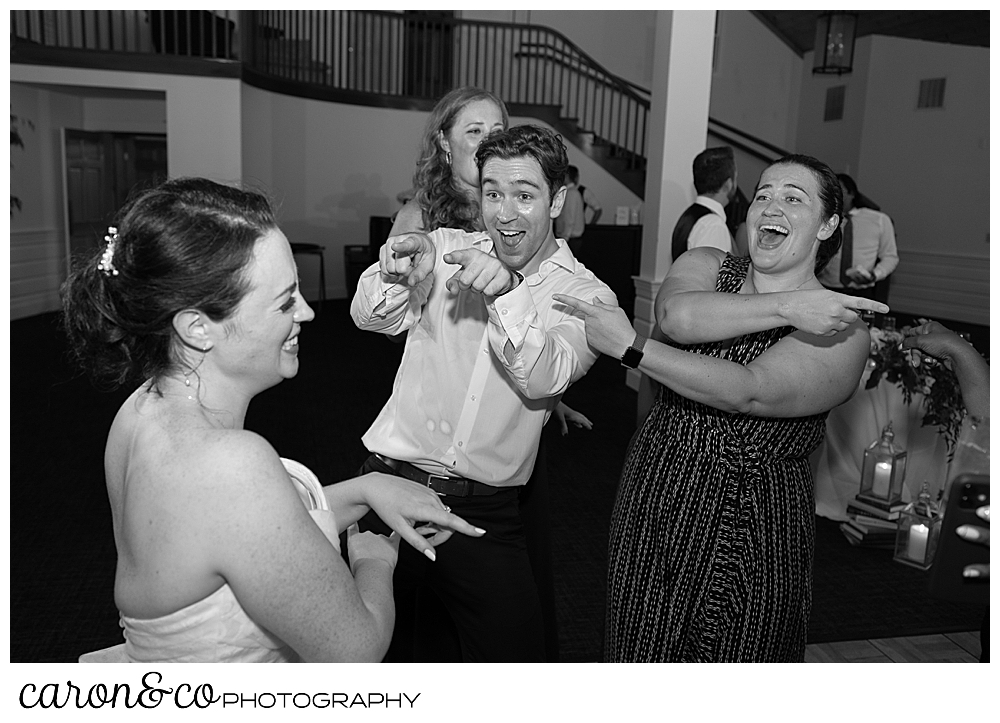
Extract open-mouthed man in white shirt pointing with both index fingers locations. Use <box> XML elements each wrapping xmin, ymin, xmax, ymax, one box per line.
<box><xmin>351</xmin><ymin>126</ymin><xmax>617</xmax><ymax>662</ymax></box>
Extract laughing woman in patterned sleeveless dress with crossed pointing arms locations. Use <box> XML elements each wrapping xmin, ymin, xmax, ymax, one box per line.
<box><xmin>560</xmin><ymin>156</ymin><xmax>888</xmax><ymax>662</ymax></box>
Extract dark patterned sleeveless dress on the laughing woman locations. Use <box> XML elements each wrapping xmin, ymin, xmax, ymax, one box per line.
<box><xmin>605</xmin><ymin>256</ymin><xmax>826</xmax><ymax>662</ymax></box>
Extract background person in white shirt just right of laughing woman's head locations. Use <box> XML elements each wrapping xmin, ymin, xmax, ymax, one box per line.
<box><xmin>819</xmin><ymin>173</ymin><xmax>899</xmax><ymax>303</ymax></box>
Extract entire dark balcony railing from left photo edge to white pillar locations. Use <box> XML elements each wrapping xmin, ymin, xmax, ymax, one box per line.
<box><xmin>11</xmin><ymin>10</ymin><xmax>649</xmax><ymax>184</ymax></box>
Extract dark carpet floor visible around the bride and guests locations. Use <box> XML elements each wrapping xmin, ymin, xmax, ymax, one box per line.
<box><xmin>10</xmin><ymin>301</ymin><xmax>983</xmax><ymax>662</ymax></box>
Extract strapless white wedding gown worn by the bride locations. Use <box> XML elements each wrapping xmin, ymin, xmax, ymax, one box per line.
<box><xmin>80</xmin><ymin>459</ymin><xmax>340</xmax><ymax>663</ymax></box>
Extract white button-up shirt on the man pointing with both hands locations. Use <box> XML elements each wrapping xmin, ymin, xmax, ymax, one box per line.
<box><xmin>351</xmin><ymin>229</ymin><xmax>617</xmax><ymax>487</ymax></box>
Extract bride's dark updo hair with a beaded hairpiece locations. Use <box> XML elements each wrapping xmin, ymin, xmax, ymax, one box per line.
<box><xmin>62</xmin><ymin>178</ymin><xmax>277</xmax><ymax>388</ymax></box>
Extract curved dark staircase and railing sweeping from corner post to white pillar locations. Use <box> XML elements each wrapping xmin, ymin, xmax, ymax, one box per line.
<box><xmin>241</xmin><ymin>10</ymin><xmax>649</xmax><ymax>198</ymax></box>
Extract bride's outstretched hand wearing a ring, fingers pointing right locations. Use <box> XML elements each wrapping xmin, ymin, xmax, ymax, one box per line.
<box><xmin>362</xmin><ymin>472</ymin><xmax>486</xmax><ymax>560</ymax></box>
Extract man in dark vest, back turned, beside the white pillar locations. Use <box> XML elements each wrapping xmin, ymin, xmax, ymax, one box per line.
<box><xmin>671</xmin><ymin>146</ymin><xmax>736</xmax><ymax>261</ymax></box>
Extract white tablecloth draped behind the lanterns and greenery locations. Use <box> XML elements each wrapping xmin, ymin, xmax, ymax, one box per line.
<box><xmin>812</xmin><ymin>370</ymin><xmax>948</xmax><ymax>520</ymax></box>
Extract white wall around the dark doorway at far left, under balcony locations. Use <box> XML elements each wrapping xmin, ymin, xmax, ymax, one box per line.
<box><xmin>10</xmin><ymin>65</ymin><xmax>243</xmax><ymax>319</ymax></box>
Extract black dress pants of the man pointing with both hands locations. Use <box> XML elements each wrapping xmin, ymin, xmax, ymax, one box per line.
<box><xmin>360</xmin><ymin>457</ymin><xmax>545</xmax><ymax>663</ymax></box>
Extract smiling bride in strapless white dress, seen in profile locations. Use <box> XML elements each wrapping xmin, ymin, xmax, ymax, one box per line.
<box><xmin>63</xmin><ymin>179</ymin><xmax>483</xmax><ymax>662</ymax></box>
